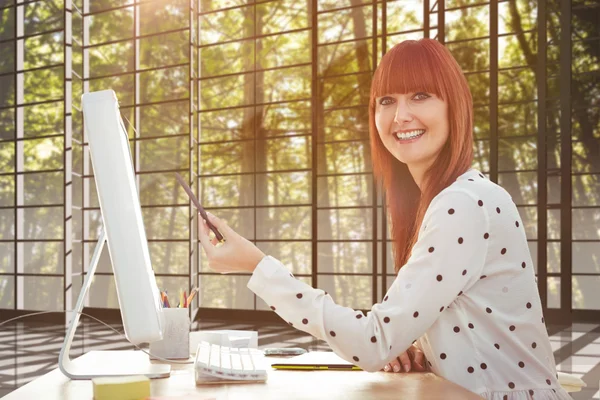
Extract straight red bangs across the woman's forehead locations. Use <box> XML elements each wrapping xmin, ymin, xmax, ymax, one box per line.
<box><xmin>372</xmin><ymin>40</ymin><xmax>446</xmax><ymax>100</ymax></box>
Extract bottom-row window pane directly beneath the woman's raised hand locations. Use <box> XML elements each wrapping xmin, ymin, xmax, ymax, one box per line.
<box><xmin>198</xmin><ymin>275</ymin><xmax>254</xmax><ymax>310</ymax></box>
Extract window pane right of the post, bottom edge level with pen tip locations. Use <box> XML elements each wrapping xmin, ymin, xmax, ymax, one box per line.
<box><xmin>200</xmin><ymin>141</ymin><xmax>254</xmax><ymax>175</ymax></box>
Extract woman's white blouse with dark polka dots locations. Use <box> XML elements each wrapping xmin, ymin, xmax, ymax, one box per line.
<box><xmin>248</xmin><ymin>169</ymin><xmax>571</xmax><ymax>400</ymax></box>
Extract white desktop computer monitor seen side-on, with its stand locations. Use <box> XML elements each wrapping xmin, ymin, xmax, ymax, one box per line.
<box><xmin>59</xmin><ymin>90</ymin><xmax>170</xmax><ymax>379</ymax></box>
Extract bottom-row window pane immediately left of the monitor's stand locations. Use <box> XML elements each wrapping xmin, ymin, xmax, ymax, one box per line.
<box><xmin>17</xmin><ymin>276</ymin><xmax>64</xmax><ymax>311</ymax></box>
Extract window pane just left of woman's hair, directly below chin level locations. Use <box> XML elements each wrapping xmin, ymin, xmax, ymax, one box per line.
<box><xmin>317</xmin><ymin>175</ymin><xmax>373</xmax><ymax>207</ymax></box>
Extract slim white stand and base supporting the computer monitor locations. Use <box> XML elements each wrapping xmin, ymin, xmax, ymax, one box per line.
<box><xmin>58</xmin><ymin>229</ymin><xmax>171</xmax><ymax>379</ymax></box>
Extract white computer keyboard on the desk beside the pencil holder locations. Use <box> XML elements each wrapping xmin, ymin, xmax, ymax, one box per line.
<box><xmin>194</xmin><ymin>341</ymin><xmax>267</xmax><ymax>385</ymax></box>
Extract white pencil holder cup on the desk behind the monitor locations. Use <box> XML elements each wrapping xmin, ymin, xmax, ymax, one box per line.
<box><xmin>150</xmin><ymin>308</ymin><xmax>190</xmax><ymax>359</ymax></box>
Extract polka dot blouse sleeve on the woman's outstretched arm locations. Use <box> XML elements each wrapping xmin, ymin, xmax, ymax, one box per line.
<box><xmin>248</xmin><ymin>189</ymin><xmax>489</xmax><ymax>372</ymax></box>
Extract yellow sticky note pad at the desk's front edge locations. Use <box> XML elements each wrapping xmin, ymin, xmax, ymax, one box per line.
<box><xmin>92</xmin><ymin>375</ymin><xmax>150</xmax><ymax>400</ymax></box>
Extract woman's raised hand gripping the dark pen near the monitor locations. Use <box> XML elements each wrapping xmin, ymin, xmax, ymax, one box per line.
<box><xmin>198</xmin><ymin>213</ymin><xmax>265</xmax><ymax>274</ymax></box>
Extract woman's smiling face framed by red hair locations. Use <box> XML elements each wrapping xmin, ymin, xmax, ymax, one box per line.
<box><xmin>375</xmin><ymin>92</ymin><xmax>449</xmax><ymax>171</ymax></box>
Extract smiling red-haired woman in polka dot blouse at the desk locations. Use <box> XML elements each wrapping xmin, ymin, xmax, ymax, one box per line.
<box><xmin>200</xmin><ymin>39</ymin><xmax>570</xmax><ymax>400</ymax></box>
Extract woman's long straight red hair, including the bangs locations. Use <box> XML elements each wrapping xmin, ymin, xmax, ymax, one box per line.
<box><xmin>369</xmin><ymin>39</ymin><xmax>473</xmax><ymax>273</ymax></box>
